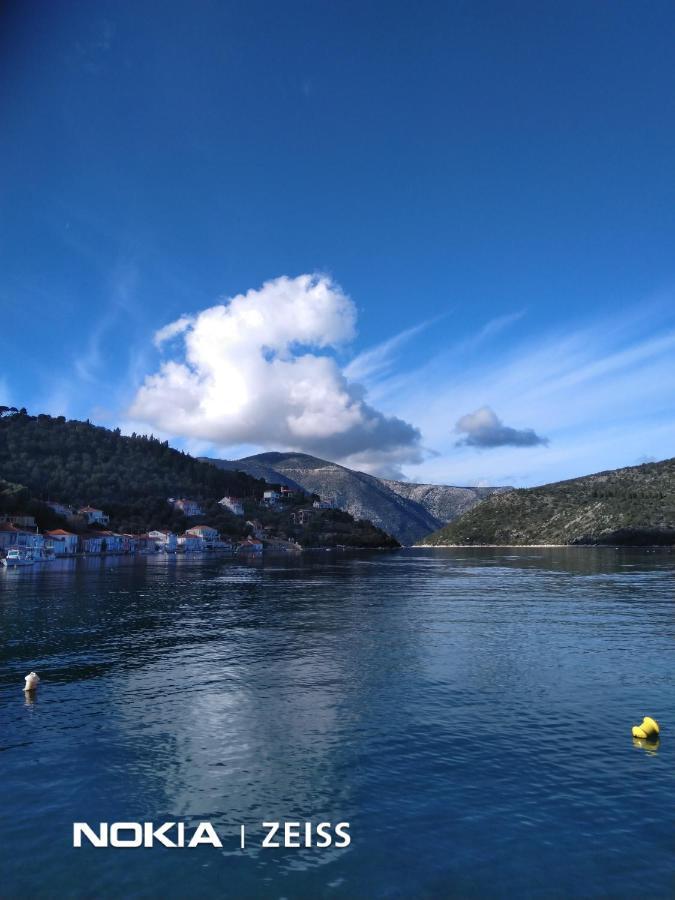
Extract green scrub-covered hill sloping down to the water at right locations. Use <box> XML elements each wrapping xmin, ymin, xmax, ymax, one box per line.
<box><xmin>423</xmin><ymin>459</ymin><xmax>675</xmax><ymax>545</ymax></box>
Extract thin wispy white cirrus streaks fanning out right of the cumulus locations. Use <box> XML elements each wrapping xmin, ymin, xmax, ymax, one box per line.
<box><xmin>364</xmin><ymin>302</ymin><xmax>675</xmax><ymax>485</ymax></box>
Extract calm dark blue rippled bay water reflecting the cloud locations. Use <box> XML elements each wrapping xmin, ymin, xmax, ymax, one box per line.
<box><xmin>0</xmin><ymin>548</ymin><xmax>675</xmax><ymax>898</ymax></box>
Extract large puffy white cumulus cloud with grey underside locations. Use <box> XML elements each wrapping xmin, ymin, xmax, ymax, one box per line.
<box><xmin>129</xmin><ymin>275</ymin><xmax>421</xmax><ymax>470</ymax></box>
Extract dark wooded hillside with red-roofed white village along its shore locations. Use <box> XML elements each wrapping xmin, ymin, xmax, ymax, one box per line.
<box><xmin>0</xmin><ymin>408</ymin><xmax>398</xmax><ymax>560</ymax></box>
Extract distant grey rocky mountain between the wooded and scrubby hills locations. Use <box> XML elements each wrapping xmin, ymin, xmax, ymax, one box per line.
<box><xmin>201</xmin><ymin>453</ymin><xmax>508</xmax><ymax>544</ymax></box>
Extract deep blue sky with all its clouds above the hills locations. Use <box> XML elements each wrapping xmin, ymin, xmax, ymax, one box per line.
<box><xmin>0</xmin><ymin>0</ymin><xmax>675</xmax><ymax>485</ymax></box>
